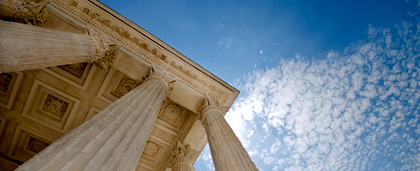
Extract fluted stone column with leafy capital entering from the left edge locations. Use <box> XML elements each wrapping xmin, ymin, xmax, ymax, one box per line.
<box><xmin>0</xmin><ymin>20</ymin><xmax>116</xmax><ymax>72</ymax></box>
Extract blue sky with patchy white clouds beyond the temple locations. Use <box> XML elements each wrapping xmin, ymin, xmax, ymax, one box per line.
<box><xmin>101</xmin><ymin>0</ymin><xmax>420</xmax><ymax>170</ymax></box>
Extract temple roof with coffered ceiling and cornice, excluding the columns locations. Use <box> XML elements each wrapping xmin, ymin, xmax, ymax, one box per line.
<box><xmin>0</xmin><ymin>0</ymin><xmax>239</xmax><ymax>170</ymax></box>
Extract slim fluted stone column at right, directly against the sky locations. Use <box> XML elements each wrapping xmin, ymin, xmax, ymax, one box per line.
<box><xmin>200</xmin><ymin>96</ymin><xmax>258</xmax><ymax>171</ymax></box>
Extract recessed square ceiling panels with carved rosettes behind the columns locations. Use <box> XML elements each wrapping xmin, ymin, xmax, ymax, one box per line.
<box><xmin>0</xmin><ymin>63</ymin><xmax>196</xmax><ymax>170</ymax></box>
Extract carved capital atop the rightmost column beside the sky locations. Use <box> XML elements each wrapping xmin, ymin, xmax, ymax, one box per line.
<box><xmin>196</xmin><ymin>94</ymin><xmax>230</xmax><ymax>125</ymax></box>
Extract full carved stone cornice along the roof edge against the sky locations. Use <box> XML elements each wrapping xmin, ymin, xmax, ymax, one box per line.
<box><xmin>51</xmin><ymin>0</ymin><xmax>239</xmax><ymax>106</ymax></box>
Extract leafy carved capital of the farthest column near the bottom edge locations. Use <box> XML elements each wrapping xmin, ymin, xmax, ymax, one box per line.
<box><xmin>169</xmin><ymin>141</ymin><xmax>200</xmax><ymax>167</ymax></box>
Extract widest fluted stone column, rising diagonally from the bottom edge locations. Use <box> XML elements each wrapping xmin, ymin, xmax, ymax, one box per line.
<box><xmin>17</xmin><ymin>67</ymin><xmax>174</xmax><ymax>171</ymax></box>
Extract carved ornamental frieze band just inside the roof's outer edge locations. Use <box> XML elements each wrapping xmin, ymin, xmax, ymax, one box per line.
<box><xmin>51</xmin><ymin>0</ymin><xmax>230</xmax><ymax>103</ymax></box>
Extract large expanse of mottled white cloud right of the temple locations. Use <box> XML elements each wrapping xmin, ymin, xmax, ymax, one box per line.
<box><xmin>228</xmin><ymin>17</ymin><xmax>420</xmax><ymax>170</ymax></box>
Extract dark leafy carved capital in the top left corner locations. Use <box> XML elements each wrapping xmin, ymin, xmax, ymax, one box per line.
<box><xmin>0</xmin><ymin>0</ymin><xmax>51</xmax><ymax>25</ymax></box>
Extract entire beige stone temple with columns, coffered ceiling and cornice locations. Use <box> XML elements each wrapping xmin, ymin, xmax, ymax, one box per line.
<box><xmin>0</xmin><ymin>0</ymin><xmax>258</xmax><ymax>171</ymax></box>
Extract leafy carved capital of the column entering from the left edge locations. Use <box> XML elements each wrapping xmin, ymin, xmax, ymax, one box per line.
<box><xmin>86</xmin><ymin>28</ymin><xmax>118</xmax><ymax>72</ymax></box>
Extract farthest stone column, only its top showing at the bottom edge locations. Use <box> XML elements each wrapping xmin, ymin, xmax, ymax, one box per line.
<box><xmin>170</xmin><ymin>141</ymin><xmax>200</xmax><ymax>171</ymax></box>
